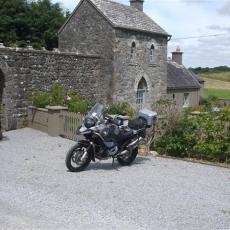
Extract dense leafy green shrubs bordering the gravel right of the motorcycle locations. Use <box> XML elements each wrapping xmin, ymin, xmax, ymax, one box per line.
<box><xmin>155</xmin><ymin>108</ymin><xmax>230</xmax><ymax>163</ymax></box>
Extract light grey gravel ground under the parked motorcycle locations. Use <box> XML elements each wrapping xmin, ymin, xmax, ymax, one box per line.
<box><xmin>0</xmin><ymin>128</ymin><xmax>230</xmax><ymax>230</ymax></box>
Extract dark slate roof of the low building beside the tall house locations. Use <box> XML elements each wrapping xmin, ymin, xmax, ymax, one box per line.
<box><xmin>167</xmin><ymin>61</ymin><xmax>201</xmax><ymax>89</ymax></box>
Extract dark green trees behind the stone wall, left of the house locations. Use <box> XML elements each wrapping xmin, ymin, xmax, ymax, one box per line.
<box><xmin>0</xmin><ymin>0</ymin><xmax>69</xmax><ymax>50</ymax></box>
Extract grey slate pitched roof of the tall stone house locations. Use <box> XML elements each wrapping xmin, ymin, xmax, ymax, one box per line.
<box><xmin>59</xmin><ymin>0</ymin><xmax>169</xmax><ymax>36</ymax></box>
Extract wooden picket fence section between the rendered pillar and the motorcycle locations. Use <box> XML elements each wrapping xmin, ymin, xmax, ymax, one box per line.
<box><xmin>60</xmin><ymin>111</ymin><xmax>84</xmax><ymax>141</ymax></box>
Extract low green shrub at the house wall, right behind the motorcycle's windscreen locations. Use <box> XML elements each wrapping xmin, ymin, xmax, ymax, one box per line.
<box><xmin>106</xmin><ymin>102</ymin><xmax>137</xmax><ymax>117</ymax></box>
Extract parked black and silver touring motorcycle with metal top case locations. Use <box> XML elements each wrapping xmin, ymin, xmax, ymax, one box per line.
<box><xmin>65</xmin><ymin>103</ymin><xmax>157</xmax><ymax>172</ymax></box>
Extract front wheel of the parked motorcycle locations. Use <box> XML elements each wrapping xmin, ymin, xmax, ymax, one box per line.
<box><xmin>65</xmin><ymin>144</ymin><xmax>91</xmax><ymax>172</ymax></box>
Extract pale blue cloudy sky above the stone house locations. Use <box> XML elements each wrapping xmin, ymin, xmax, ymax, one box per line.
<box><xmin>52</xmin><ymin>0</ymin><xmax>230</xmax><ymax>67</ymax></box>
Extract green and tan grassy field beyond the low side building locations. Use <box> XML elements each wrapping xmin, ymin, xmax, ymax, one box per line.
<box><xmin>199</xmin><ymin>72</ymin><xmax>230</xmax><ymax>99</ymax></box>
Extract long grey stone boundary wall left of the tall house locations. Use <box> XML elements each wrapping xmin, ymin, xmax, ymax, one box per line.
<box><xmin>0</xmin><ymin>47</ymin><xmax>106</xmax><ymax>130</ymax></box>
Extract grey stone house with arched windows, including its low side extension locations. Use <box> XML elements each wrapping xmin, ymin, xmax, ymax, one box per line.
<box><xmin>59</xmin><ymin>0</ymin><xmax>200</xmax><ymax>108</ymax></box>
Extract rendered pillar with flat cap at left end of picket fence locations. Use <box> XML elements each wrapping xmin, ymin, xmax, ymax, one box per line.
<box><xmin>46</xmin><ymin>106</ymin><xmax>67</xmax><ymax>137</ymax></box>
